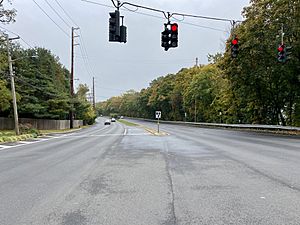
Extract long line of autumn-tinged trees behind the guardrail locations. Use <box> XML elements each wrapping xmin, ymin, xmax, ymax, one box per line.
<box><xmin>97</xmin><ymin>0</ymin><xmax>300</xmax><ymax>126</ymax></box>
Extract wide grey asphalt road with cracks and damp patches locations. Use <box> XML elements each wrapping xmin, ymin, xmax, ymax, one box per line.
<box><xmin>0</xmin><ymin>118</ymin><xmax>300</xmax><ymax>225</ymax></box>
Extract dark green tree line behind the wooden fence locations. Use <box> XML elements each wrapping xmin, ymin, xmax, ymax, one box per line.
<box><xmin>0</xmin><ymin>41</ymin><xmax>96</xmax><ymax>124</ymax></box>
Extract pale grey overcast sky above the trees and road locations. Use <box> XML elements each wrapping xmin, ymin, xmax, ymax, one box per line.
<box><xmin>2</xmin><ymin>0</ymin><xmax>249</xmax><ymax>101</ymax></box>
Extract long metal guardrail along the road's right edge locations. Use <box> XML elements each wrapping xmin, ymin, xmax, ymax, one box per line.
<box><xmin>131</xmin><ymin>118</ymin><xmax>300</xmax><ymax>133</ymax></box>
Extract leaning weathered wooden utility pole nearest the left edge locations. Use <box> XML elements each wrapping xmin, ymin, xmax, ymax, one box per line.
<box><xmin>6</xmin><ymin>35</ymin><xmax>20</xmax><ymax>135</ymax></box>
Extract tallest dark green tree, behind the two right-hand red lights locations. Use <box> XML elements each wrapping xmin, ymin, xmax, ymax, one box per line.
<box><xmin>221</xmin><ymin>0</ymin><xmax>300</xmax><ymax>125</ymax></box>
